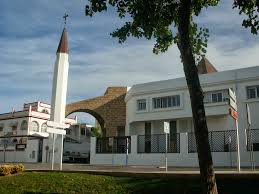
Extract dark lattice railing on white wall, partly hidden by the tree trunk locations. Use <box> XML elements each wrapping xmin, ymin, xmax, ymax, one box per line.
<box><xmin>188</xmin><ymin>130</ymin><xmax>237</xmax><ymax>153</ymax></box>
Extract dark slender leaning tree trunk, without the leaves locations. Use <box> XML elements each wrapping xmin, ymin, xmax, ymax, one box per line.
<box><xmin>178</xmin><ymin>0</ymin><xmax>218</xmax><ymax>194</ymax></box>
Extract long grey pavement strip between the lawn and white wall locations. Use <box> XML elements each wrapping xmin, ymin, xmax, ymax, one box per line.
<box><xmin>20</xmin><ymin>163</ymin><xmax>259</xmax><ymax>179</ymax></box>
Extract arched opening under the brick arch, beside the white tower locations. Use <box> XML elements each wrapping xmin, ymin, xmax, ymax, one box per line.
<box><xmin>63</xmin><ymin>109</ymin><xmax>105</xmax><ymax>163</ymax></box>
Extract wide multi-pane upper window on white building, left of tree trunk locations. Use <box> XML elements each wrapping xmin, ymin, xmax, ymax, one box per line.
<box><xmin>153</xmin><ymin>95</ymin><xmax>180</xmax><ymax>109</ymax></box>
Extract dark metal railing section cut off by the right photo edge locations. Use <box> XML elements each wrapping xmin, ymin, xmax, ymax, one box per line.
<box><xmin>246</xmin><ymin>129</ymin><xmax>259</xmax><ymax>151</ymax></box>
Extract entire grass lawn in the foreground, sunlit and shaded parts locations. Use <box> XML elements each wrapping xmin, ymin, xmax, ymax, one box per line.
<box><xmin>0</xmin><ymin>172</ymin><xmax>259</xmax><ymax>194</ymax></box>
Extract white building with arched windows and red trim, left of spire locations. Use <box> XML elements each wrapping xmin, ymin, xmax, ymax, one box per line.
<box><xmin>0</xmin><ymin>101</ymin><xmax>77</xmax><ymax>162</ymax></box>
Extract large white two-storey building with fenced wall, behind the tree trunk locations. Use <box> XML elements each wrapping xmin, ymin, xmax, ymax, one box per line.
<box><xmin>91</xmin><ymin>57</ymin><xmax>259</xmax><ymax>167</ymax></box>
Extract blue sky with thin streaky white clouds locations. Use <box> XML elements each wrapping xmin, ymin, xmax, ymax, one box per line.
<box><xmin>0</xmin><ymin>0</ymin><xmax>259</xmax><ymax>122</ymax></box>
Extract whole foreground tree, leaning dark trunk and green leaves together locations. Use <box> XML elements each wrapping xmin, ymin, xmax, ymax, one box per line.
<box><xmin>85</xmin><ymin>0</ymin><xmax>259</xmax><ymax>193</ymax></box>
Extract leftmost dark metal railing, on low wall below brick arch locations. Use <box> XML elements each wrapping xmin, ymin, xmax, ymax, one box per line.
<box><xmin>96</xmin><ymin>136</ymin><xmax>131</xmax><ymax>154</ymax></box>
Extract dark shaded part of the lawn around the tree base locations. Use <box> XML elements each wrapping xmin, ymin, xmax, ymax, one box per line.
<box><xmin>117</xmin><ymin>177</ymin><xmax>259</xmax><ymax>194</ymax></box>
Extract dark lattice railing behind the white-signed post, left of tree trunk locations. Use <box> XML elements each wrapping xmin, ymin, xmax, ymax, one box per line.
<box><xmin>138</xmin><ymin>133</ymin><xmax>180</xmax><ymax>153</ymax></box>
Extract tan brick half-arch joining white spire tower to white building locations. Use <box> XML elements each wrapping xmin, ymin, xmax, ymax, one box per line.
<box><xmin>66</xmin><ymin>87</ymin><xmax>127</xmax><ymax>137</ymax></box>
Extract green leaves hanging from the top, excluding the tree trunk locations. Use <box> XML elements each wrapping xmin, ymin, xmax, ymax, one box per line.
<box><xmin>85</xmin><ymin>0</ymin><xmax>259</xmax><ymax>57</ymax></box>
